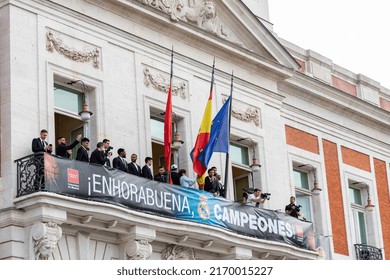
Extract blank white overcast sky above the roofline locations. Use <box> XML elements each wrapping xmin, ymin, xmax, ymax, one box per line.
<box><xmin>268</xmin><ymin>0</ymin><xmax>390</xmax><ymax>89</ymax></box>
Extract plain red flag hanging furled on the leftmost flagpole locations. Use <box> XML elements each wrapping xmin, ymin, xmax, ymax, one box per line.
<box><xmin>164</xmin><ymin>49</ymin><xmax>173</xmax><ymax>184</ymax></box>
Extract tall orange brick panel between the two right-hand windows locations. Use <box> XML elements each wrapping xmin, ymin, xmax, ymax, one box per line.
<box><xmin>322</xmin><ymin>140</ymin><xmax>348</xmax><ymax>256</ymax></box>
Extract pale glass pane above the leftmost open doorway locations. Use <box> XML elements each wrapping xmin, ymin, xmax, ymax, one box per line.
<box><xmin>54</xmin><ymin>84</ymin><xmax>83</xmax><ymax>114</ymax></box>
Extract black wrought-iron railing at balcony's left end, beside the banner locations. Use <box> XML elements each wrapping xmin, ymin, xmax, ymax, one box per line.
<box><xmin>15</xmin><ymin>152</ymin><xmax>45</xmax><ymax>197</ymax></box>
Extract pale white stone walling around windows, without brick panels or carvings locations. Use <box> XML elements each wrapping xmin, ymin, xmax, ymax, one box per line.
<box><xmin>0</xmin><ymin>0</ymin><xmax>389</xmax><ymax>259</ymax></box>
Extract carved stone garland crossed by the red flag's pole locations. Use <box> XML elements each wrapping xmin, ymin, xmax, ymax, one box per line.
<box><xmin>144</xmin><ymin>67</ymin><xmax>187</xmax><ymax>99</ymax></box>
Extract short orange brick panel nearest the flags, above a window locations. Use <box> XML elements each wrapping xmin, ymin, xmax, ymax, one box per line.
<box><xmin>285</xmin><ymin>125</ymin><xmax>320</xmax><ymax>154</ymax></box>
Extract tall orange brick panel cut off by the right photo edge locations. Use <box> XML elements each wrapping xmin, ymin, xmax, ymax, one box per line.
<box><xmin>374</xmin><ymin>158</ymin><xmax>390</xmax><ymax>260</ymax></box>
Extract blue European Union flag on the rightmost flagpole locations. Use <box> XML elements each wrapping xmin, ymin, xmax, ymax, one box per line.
<box><xmin>198</xmin><ymin>96</ymin><xmax>231</xmax><ymax>168</ymax></box>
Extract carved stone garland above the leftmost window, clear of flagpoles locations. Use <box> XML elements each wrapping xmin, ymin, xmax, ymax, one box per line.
<box><xmin>46</xmin><ymin>31</ymin><xmax>100</xmax><ymax>68</ymax></box>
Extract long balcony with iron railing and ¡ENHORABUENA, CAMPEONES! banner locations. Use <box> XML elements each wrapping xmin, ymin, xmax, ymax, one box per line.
<box><xmin>15</xmin><ymin>153</ymin><xmax>318</xmax><ymax>259</ymax></box>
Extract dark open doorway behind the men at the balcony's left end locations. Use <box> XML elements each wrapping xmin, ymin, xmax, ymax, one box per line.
<box><xmin>54</xmin><ymin>113</ymin><xmax>84</xmax><ymax>159</ymax></box>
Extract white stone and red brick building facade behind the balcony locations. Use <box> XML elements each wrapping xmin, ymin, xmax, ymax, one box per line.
<box><xmin>0</xmin><ymin>0</ymin><xmax>390</xmax><ymax>259</ymax></box>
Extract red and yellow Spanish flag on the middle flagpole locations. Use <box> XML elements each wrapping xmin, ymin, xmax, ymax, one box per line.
<box><xmin>190</xmin><ymin>60</ymin><xmax>215</xmax><ymax>190</ymax></box>
